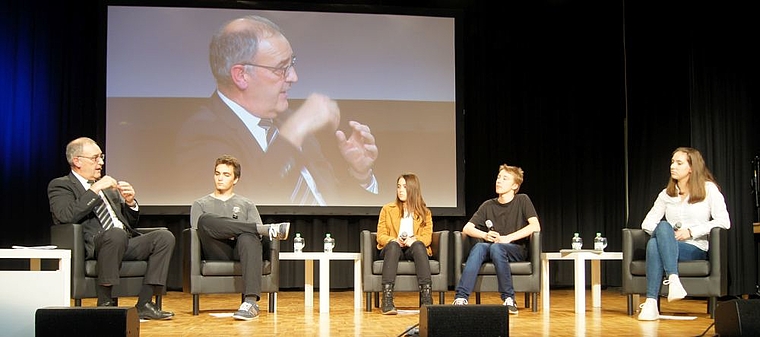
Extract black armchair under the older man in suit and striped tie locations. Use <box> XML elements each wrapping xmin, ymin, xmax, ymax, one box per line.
<box><xmin>50</xmin><ymin>224</ymin><xmax>166</xmax><ymax>307</ymax></box>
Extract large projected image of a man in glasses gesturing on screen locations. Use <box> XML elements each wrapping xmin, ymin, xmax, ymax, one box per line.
<box><xmin>176</xmin><ymin>15</ymin><xmax>378</xmax><ymax>206</ymax></box>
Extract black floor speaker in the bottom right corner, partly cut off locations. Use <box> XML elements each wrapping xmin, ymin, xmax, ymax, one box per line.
<box><xmin>715</xmin><ymin>299</ymin><xmax>760</xmax><ymax>337</ymax></box>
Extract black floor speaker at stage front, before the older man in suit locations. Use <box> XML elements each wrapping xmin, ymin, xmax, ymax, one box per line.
<box><xmin>34</xmin><ymin>307</ymin><xmax>140</xmax><ymax>337</ymax></box>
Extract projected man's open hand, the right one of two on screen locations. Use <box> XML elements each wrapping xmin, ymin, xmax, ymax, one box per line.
<box><xmin>335</xmin><ymin>121</ymin><xmax>378</xmax><ymax>181</ymax></box>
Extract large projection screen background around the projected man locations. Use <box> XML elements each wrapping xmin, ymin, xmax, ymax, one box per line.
<box><xmin>104</xmin><ymin>5</ymin><xmax>464</xmax><ymax>215</ymax></box>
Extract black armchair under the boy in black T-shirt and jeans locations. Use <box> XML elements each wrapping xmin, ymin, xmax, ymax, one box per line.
<box><xmin>454</xmin><ymin>231</ymin><xmax>543</xmax><ymax>311</ymax></box>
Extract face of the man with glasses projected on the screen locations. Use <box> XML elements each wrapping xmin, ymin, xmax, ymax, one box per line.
<box><xmin>245</xmin><ymin>35</ymin><xmax>298</xmax><ymax>118</ymax></box>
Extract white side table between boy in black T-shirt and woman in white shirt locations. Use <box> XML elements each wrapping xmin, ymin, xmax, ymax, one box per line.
<box><xmin>541</xmin><ymin>249</ymin><xmax>623</xmax><ymax>314</ymax></box>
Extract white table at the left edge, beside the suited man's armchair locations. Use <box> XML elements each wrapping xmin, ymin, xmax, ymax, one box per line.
<box><xmin>0</xmin><ymin>249</ymin><xmax>71</xmax><ymax>336</ymax></box>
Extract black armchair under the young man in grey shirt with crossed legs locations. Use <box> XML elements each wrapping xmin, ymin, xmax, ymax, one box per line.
<box><xmin>182</xmin><ymin>228</ymin><xmax>280</xmax><ymax>315</ymax></box>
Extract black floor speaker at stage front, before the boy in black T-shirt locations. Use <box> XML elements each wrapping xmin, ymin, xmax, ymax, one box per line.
<box><xmin>420</xmin><ymin>304</ymin><xmax>509</xmax><ymax>337</ymax></box>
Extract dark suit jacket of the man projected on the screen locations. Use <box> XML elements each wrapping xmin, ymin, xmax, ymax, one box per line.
<box><xmin>175</xmin><ymin>92</ymin><xmax>367</xmax><ymax>205</ymax></box>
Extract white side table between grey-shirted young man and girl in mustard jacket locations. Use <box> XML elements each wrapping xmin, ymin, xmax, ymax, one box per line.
<box><xmin>280</xmin><ymin>252</ymin><xmax>363</xmax><ymax>313</ymax></box>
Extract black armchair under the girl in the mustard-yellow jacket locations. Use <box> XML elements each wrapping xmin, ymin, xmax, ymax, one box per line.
<box><xmin>359</xmin><ymin>230</ymin><xmax>451</xmax><ymax>311</ymax></box>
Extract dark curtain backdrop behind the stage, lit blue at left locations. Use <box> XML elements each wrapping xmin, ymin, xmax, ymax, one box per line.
<box><xmin>0</xmin><ymin>0</ymin><xmax>760</xmax><ymax>295</ymax></box>
